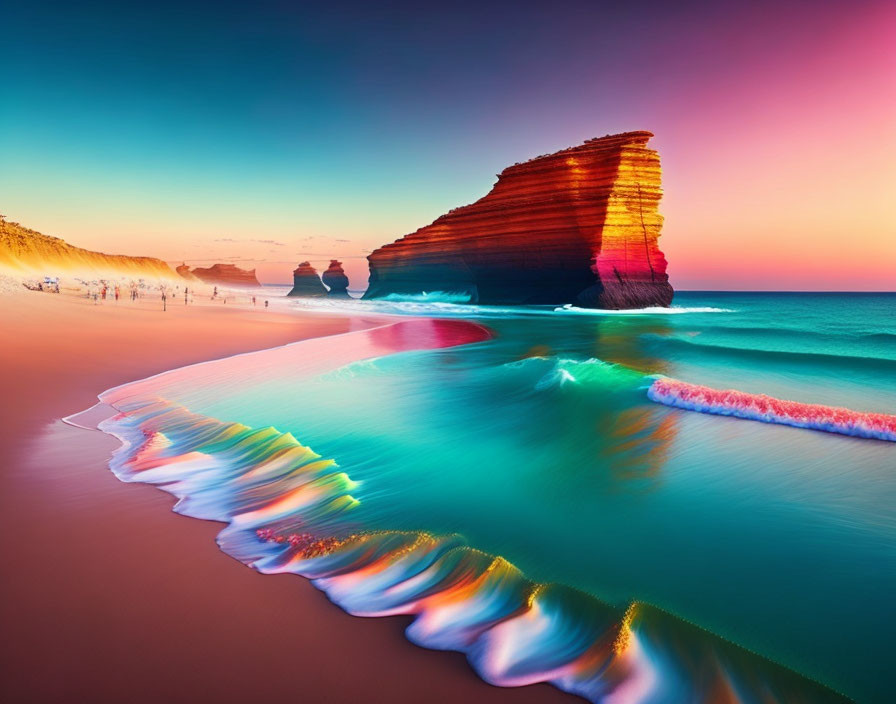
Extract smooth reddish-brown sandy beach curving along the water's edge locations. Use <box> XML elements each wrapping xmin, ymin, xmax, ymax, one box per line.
<box><xmin>0</xmin><ymin>291</ymin><xmax>574</xmax><ymax>703</ymax></box>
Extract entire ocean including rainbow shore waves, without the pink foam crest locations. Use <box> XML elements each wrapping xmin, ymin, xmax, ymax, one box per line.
<box><xmin>93</xmin><ymin>292</ymin><xmax>896</xmax><ymax>702</ymax></box>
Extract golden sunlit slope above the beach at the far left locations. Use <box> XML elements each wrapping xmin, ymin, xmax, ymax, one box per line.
<box><xmin>0</xmin><ymin>220</ymin><xmax>176</xmax><ymax>279</ymax></box>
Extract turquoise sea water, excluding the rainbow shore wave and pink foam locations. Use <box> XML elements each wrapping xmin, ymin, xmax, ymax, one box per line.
<box><xmin>100</xmin><ymin>293</ymin><xmax>896</xmax><ymax>701</ymax></box>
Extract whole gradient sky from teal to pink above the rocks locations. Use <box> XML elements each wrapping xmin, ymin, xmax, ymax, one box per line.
<box><xmin>0</xmin><ymin>0</ymin><xmax>896</xmax><ymax>290</ymax></box>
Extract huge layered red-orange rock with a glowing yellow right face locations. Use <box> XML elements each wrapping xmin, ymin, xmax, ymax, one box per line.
<box><xmin>364</xmin><ymin>132</ymin><xmax>673</xmax><ymax>309</ymax></box>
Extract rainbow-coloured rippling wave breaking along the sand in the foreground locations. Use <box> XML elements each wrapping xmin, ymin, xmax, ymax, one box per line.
<box><xmin>100</xmin><ymin>398</ymin><xmax>844</xmax><ymax>703</ymax></box>
